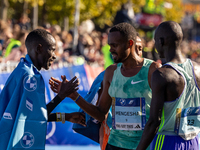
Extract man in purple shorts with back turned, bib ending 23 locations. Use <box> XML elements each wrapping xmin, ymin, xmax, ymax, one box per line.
<box><xmin>137</xmin><ymin>21</ymin><xmax>200</xmax><ymax>150</ymax></box>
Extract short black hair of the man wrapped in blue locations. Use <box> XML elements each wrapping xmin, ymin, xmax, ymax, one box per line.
<box><xmin>25</xmin><ymin>29</ymin><xmax>52</xmax><ymax>50</ymax></box>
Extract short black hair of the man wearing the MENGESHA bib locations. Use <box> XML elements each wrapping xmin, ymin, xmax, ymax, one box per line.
<box><xmin>109</xmin><ymin>22</ymin><xmax>137</xmax><ymax>41</ymax></box>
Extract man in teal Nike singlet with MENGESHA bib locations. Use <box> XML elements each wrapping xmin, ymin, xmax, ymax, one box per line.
<box><xmin>52</xmin><ymin>23</ymin><xmax>160</xmax><ymax>150</ymax></box>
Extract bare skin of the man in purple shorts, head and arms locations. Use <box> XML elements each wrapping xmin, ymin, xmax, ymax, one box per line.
<box><xmin>137</xmin><ymin>22</ymin><xmax>200</xmax><ymax>150</ymax></box>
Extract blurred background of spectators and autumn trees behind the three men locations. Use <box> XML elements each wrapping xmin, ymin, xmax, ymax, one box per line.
<box><xmin>0</xmin><ymin>0</ymin><xmax>200</xmax><ymax>68</ymax></box>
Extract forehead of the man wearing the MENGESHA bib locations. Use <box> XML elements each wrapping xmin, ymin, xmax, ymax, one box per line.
<box><xmin>108</xmin><ymin>31</ymin><xmax>123</xmax><ymax>44</ymax></box>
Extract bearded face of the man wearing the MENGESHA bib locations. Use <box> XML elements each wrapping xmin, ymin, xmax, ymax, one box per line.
<box><xmin>108</xmin><ymin>31</ymin><xmax>130</xmax><ymax>63</ymax></box>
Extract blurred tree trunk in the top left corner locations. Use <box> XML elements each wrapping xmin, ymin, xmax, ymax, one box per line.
<box><xmin>0</xmin><ymin>0</ymin><xmax>9</xmax><ymax>21</ymax></box>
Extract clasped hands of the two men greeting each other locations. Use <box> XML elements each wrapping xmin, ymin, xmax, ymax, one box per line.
<box><xmin>49</xmin><ymin>76</ymin><xmax>79</xmax><ymax>99</ymax></box>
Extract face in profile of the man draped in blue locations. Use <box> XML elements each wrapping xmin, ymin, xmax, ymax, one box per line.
<box><xmin>38</xmin><ymin>35</ymin><xmax>56</xmax><ymax>70</ymax></box>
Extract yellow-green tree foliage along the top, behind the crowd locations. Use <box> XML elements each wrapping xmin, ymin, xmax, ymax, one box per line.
<box><xmin>8</xmin><ymin>0</ymin><xmax>183</xmax><ymax>28</ymax></box>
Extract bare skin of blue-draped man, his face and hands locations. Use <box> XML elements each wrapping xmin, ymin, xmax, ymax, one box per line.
<box><xmin>26</xmin><ymin>31</ymin><xmax>85</xmax><ymax>125</ymax></box>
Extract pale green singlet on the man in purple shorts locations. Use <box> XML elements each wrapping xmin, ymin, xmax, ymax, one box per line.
<box><xmin>158</xmin><ymin>59</ymin><xmax>200</xmax><ymax>138</ymax></box>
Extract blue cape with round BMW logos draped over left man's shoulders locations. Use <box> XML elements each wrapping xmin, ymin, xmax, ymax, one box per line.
<box><xmin>0</xmin><ymin>55</ymin><xmax>47</xmax><ymax>150</ymax></box>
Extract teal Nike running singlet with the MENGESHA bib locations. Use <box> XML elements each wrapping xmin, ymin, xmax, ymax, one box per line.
<box><xmin>108</xmin><ymin>59</ymin><xmax>153</xmax><ymax>149</ymax></box>
